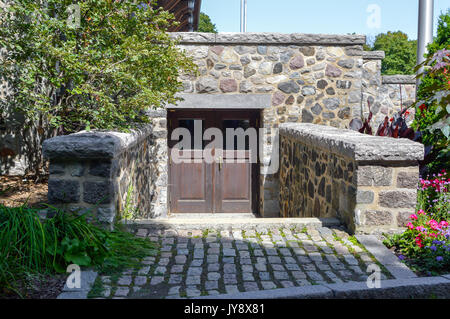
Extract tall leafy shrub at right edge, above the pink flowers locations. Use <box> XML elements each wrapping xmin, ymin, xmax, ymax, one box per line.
<box><xmin>413</xmin><ymin>10</ymin><xmax>450</xmax><ymax>173</ymax></box>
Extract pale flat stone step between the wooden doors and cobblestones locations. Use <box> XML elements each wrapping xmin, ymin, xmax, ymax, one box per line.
<box><xmin>119</xmin><ymin>214</ymin><xmax>341</xmax><ymax>230</ymax></box>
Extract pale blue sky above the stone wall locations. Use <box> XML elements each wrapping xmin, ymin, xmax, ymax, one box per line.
<box><xmin>201</xmin><ymin>0</ymin><xmax>450</xmax><ymax>39</ymax></box>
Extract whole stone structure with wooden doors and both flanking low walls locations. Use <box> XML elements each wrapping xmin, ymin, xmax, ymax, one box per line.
<box><xmin>40</xmin><ymin>32</ymin><xmax>423</xmax><ymax>232</ymax></box>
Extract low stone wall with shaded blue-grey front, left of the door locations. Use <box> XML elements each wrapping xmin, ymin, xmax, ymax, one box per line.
<box><xmin>43</xmin><ymin>125</ymin><xmax>160</xmax><ymax>224</ymax></box>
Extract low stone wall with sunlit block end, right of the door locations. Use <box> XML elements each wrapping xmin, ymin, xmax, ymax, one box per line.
<box><xmin>279</xmin><ymin>123</ymin><xmax>424</xmax><ymax>233</ymax></box>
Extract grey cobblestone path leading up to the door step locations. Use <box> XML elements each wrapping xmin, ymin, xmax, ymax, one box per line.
<box><xmin>90</xmin><ymin>227</ymin><xmax>392</xmax><ymax>298</ymax></box>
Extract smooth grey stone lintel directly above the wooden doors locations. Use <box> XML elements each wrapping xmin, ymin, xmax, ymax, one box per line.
<box><xmin>167</xmin><ymin>93</ymin><xmax>271</xmax><ymax>110</ymax></box>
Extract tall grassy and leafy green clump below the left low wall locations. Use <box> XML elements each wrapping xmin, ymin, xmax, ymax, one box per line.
<box><xmin>0</xmin><ymin>206</ymin><xmax>108</xmax><ymax>294</ymax></box>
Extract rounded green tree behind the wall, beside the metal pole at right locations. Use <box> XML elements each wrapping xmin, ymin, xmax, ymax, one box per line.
<box><xmin>372</xmin><ymin>31</ymin><xmax>417</xmax><ymax>75</ymax></box>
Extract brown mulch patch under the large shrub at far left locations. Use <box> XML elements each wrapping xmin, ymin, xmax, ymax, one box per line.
<box><xmin>0</xmin><ymin>176</ymin><xmax>48</xmax><ymax>207</ymax></box>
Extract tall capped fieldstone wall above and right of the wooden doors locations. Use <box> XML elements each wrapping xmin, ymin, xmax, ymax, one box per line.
<box><xmin>173</xmin><ymin>33</ymin><xmax>365</xmax><ymax>217</ymax></box>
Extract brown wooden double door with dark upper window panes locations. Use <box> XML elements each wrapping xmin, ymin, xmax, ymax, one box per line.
<box><xmin>168</xmin><ymin>109</ymin><xmax>260</xmax><ymax>213</ymax></box>
